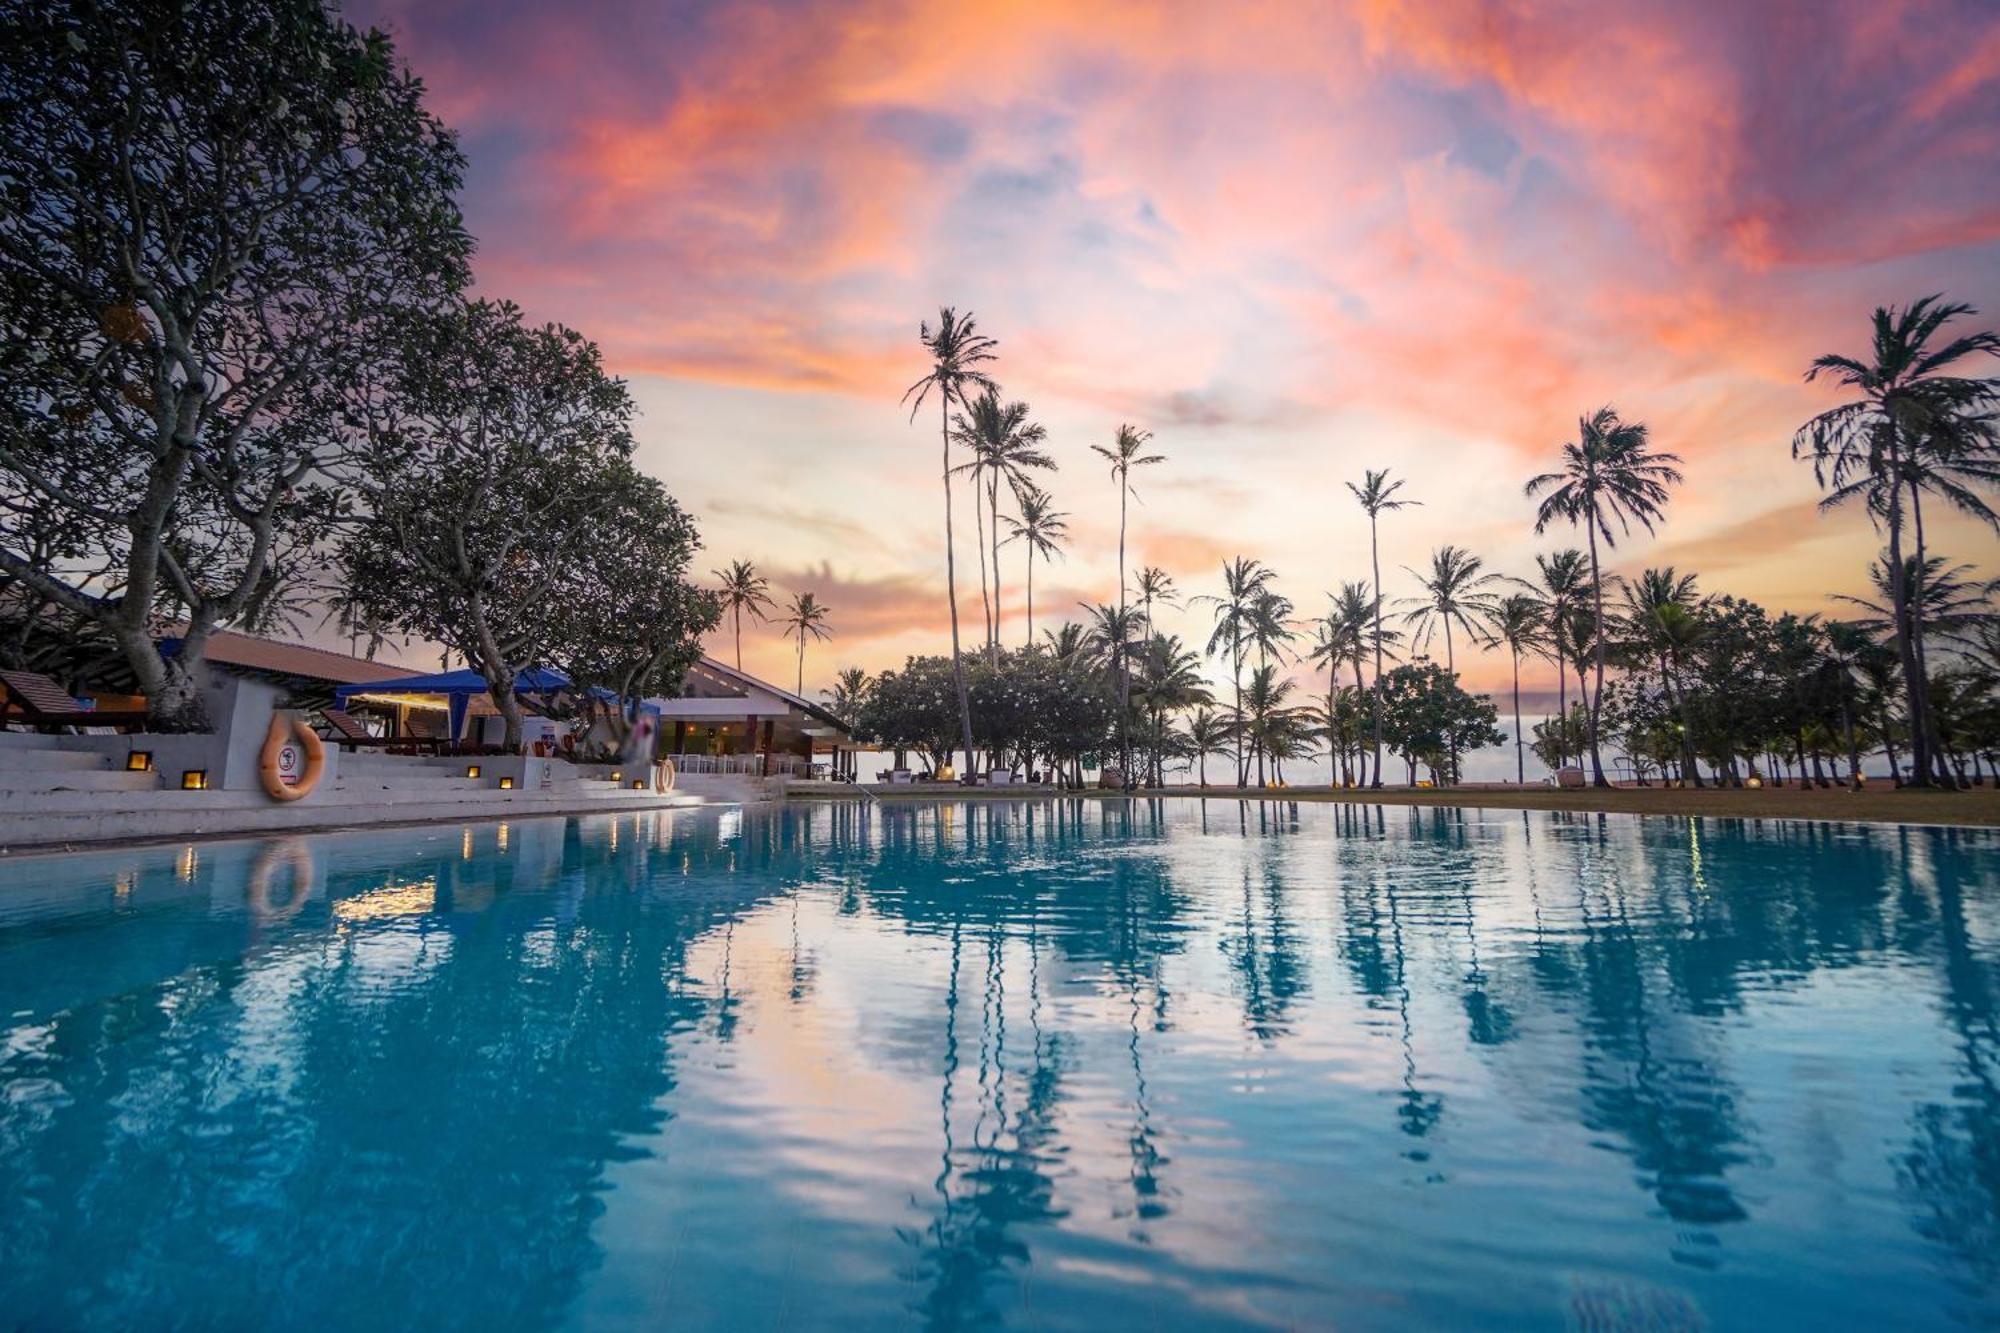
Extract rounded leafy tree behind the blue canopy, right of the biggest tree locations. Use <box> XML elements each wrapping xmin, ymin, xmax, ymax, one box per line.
<box><xmin>342</xmin><ymin>300</ymin><xmax>638</xmax><ymax>749</ymax></box>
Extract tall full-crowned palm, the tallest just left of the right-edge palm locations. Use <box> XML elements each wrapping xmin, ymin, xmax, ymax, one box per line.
<box><xmin>1526</xmin><ymin>406</ymin><xmax>1680</xmax><ymax>787</ymax></box>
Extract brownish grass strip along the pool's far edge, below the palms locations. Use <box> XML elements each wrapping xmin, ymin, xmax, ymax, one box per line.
<box><xmin>820</xmin><ymin>783</ymin><xmax>2000</xmax><ymax>829</ymax></box>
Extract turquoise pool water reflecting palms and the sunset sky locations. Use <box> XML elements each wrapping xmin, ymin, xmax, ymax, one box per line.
<box><xmin>0</xmin><ymin>803</ymin><xmax>2000</xmax><ymax>1329</ymax></box>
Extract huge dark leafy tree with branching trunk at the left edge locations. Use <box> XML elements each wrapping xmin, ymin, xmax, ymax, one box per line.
<box><xmin>0</xmin><ymin>0</ymin><xmax>470</xmax><ymax>731</ymax></box>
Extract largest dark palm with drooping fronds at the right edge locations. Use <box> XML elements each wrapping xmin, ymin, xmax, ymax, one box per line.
<box><xmin>1792</xmin><ymin>294</ymin><xmax>2000</xmax><ymax>787</ymax></box>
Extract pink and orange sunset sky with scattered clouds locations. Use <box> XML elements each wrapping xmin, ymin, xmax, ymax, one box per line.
<box><xmin>348</xmin><ymin>0</ymin><xmax>2000</xmax><ymax>704</ymax></box>
